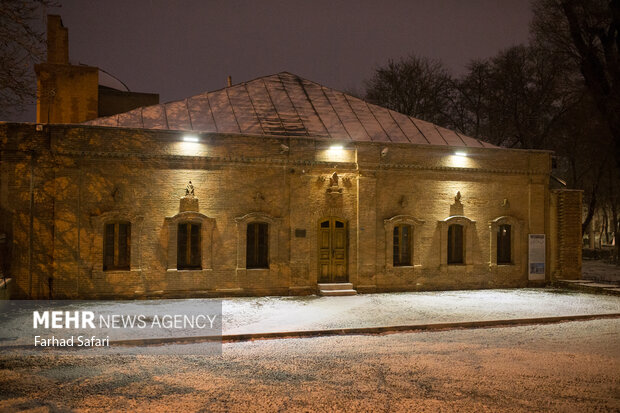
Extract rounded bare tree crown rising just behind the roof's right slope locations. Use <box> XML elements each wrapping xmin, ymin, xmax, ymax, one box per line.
<box><xmin>366</xmin><ymin>55</ymin><xmax>454</xmax><ymax>125</ymax></box>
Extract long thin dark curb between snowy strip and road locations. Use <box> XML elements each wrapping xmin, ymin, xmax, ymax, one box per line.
<box><xmin>110</xmin><ymin>313</ymin><xmax>620</xmax><ymax>346</ymax></box>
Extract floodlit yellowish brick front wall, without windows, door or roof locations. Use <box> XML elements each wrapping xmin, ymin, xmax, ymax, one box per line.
<box><xmin>0</xmin><ymin>124</ymin><xmax>560</xmax><ymax>298</ymax></box>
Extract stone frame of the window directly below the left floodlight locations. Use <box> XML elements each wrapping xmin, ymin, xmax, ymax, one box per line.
<box><xmin>165</xmin><ymin>211</ymin><xmax>215</xmax><ymax>273</ymax></box>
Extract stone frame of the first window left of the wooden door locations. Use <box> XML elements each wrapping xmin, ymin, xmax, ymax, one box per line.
<box><xmin>235</xmin><ymin>212</ymin><xmax>281</xmax><ymax>271</ymax></box>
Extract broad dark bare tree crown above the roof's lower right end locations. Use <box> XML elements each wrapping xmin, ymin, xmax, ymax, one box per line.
<box><xmin>453</xmin><ymin>46</ymin><xmax>575</xmax><ymax>149</ymax></box>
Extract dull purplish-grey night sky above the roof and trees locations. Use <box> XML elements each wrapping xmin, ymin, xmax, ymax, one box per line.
<box><xmin>23</xmin><ymin>0</ymin><xmax>532</xmax><ymax>120</ymax></box>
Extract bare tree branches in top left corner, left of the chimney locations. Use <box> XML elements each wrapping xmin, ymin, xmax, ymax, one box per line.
<box><xmin>0</xmin><ymin>0</ymin><xmax>55</xmax><ymax>119</ymax></box>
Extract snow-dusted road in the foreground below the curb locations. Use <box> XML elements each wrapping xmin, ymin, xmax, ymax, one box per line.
<box><xmin>0</xmin><ymin>319</ymin><xmax>620</xmax><ymax>412</ymax></box>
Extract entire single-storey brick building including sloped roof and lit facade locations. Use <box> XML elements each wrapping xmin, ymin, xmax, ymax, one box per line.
<box><xmin>0</xmin><ymin>73</ymin><xmax>581</xmax><ymax>298</ymax></box>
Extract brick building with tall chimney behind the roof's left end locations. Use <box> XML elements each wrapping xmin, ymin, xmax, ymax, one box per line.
<box><xmin>35</xmin><ymin>15</ymin><xmax>159</xmax><ymax>123</ymax></box>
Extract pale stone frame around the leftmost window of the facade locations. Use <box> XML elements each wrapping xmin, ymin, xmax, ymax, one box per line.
<box><xmin>92</xmin><ymin>211</ymin><xmax>144</xmax><ymax>276</ymax></box>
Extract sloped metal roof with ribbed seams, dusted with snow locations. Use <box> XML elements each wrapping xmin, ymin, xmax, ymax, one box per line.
<box><xmin>85</xmin><ymin>72</ymin><xmax>496</xmax><ymax>148</ymax></box>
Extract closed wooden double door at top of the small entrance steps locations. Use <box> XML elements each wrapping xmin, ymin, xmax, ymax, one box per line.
<box><xmin>318</xmin><ymin>218</ymin><xmax>348</xmax><ymax>283</ymax></box>
